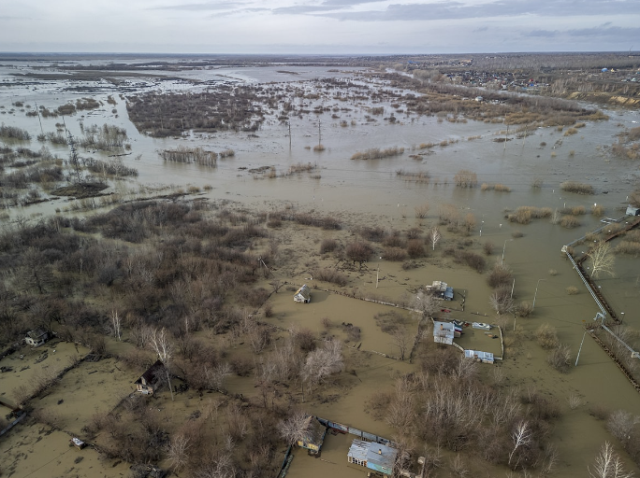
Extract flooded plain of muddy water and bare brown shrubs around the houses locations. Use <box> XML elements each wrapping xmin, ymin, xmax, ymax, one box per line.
<box><xmin>0</xmin><ymin>54</ymin><xmax>640</xmax><ymax>478</ymax></box>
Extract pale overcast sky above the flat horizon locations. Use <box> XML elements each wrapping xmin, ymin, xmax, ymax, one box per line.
<box><xmin>0</xmin><ymin>0</ymin><xmax>640</xmax><ymax>54</ymax></box>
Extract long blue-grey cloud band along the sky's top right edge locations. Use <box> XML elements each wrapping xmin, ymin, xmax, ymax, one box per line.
<box><xmin>314</xmin><ymin>0</ymin><xmax>640</xmax><ymax>21</ymax></box>
